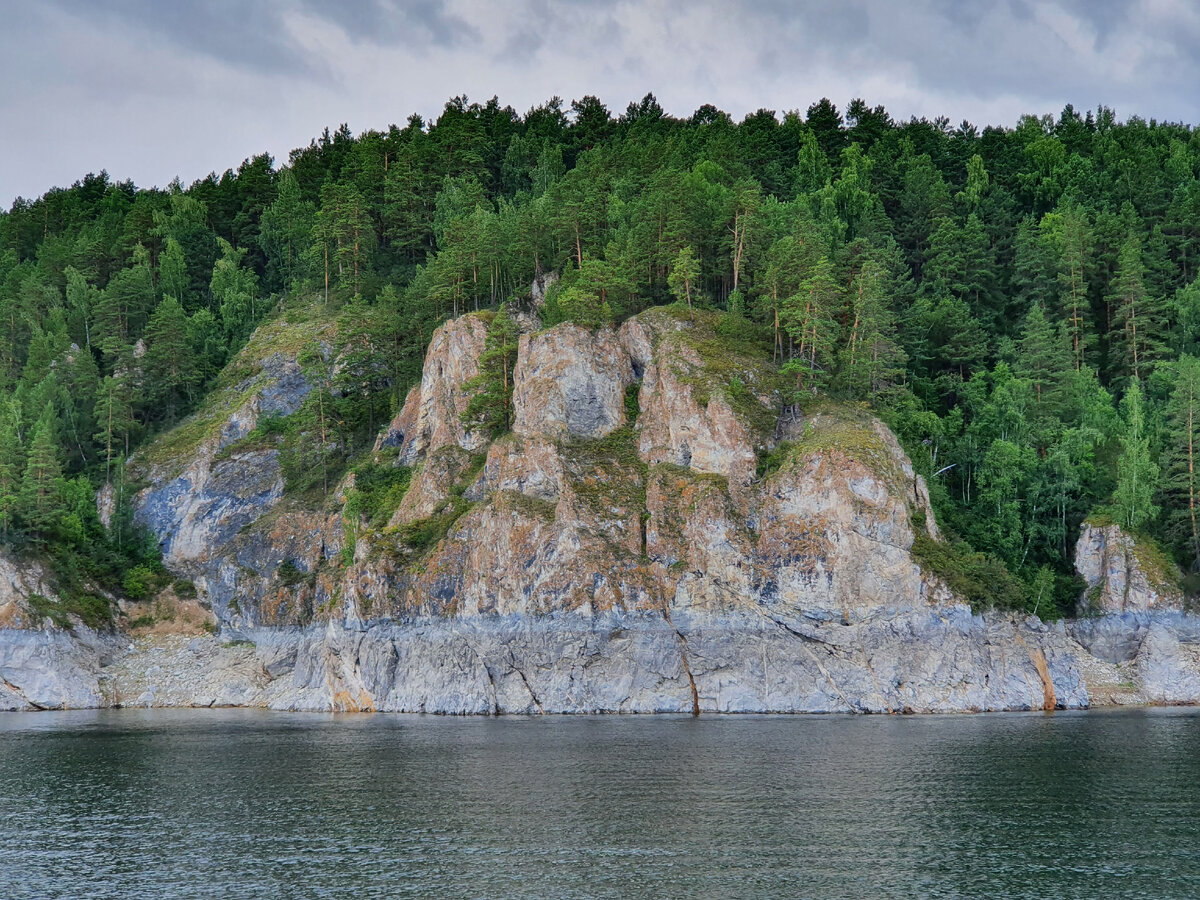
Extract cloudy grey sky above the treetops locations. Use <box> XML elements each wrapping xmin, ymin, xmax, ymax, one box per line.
<box><xmin>0</xmin><ymin>0</ymin><xmax>1200</xmax><ymax>209</ymax></box>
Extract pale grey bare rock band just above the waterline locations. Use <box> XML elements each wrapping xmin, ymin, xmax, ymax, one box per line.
<box><xmin>0</xmin><ymin>606</ymin><xmax>1200</xmax><ymax>716</ymax></box>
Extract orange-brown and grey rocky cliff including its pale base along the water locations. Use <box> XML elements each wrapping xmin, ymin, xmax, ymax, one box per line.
<box><xmin>0</xmin><ymin>308</ymin><xmax>1200</xmax><ymax>713</ymax></box>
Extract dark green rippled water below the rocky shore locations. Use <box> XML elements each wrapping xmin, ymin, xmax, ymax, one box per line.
<box><xmin>0</xmin><ymin>709</ymin><xmax>1200</xmax><ymax>900</ymax></box>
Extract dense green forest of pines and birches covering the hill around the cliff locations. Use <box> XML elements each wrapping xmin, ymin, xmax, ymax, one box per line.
<box><xmin>0</xmin><ymin>95</ymin><xmax>1200</xmax><ymax>614</ymax></box>
